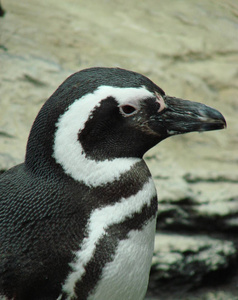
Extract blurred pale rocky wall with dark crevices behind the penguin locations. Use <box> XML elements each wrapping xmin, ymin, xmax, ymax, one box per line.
<box><xmin>0</xmin><ymin>0</ymin><xmax>238</xmax><ymax>300</ymax></box>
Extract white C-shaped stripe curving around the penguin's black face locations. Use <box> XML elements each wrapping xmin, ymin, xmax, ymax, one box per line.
<box><xmin>52</xmin><ymin>86</ymin><xmax>154</xmax><ymax>186</ymax></box>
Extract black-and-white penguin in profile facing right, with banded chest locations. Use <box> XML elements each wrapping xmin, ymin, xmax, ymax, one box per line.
<box><xmin>0</xmin><ymin>68</ymin><xmax>226</xmax><ymax>300</ymax></box>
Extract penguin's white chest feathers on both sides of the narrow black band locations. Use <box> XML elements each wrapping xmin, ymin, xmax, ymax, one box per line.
<box><xmin>59</xmin><ymin>178</ymin><xmax>156</xmax><ymax>300</ymax></box>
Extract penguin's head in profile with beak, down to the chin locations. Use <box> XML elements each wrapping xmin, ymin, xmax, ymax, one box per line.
<box><xmin>26</xmin><ymin>68</ymin><xmax>226</xmax><ymax>176</ymax></box>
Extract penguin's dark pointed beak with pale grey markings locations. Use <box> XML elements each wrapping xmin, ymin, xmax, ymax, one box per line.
<box><xmin>154</xmin><ymin>95</ymin><xmax>226</xmax><ymax>136</ymax></box>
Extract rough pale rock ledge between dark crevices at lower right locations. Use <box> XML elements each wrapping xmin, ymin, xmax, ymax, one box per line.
<box><xmin>150</xmin><ymin>233</ymin><xmax>237</xmax><ymax>291</ymax></box>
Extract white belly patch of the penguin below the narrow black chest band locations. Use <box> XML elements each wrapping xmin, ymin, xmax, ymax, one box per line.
<box><xmin>88</xmin><ymin>219</ymin><xmax>156</xmax><ymax>300</ymax></box>
